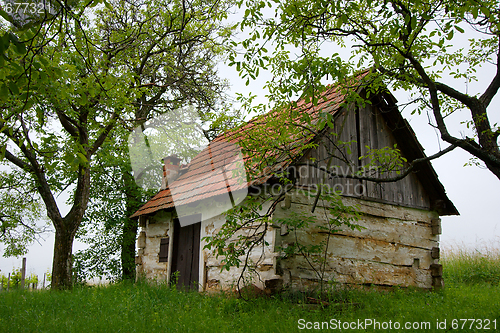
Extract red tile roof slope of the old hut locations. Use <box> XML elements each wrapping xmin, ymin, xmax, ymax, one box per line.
<box><xmin>131</xmin><ymin>71</ymin><xmax>368</xmax><ymax>218</ymax></box>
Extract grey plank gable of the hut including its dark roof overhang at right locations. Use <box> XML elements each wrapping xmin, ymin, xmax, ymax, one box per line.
<box><xmin>298</xmin><ymin>89</ymin><xmax>458</xmax><ymax>215</ymax></box>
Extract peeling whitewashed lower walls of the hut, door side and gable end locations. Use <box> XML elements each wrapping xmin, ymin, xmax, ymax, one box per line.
<box><xmin>137</xmin><ymin>192</ymin><xmax>442</xmax><ymax>291</ymax></box>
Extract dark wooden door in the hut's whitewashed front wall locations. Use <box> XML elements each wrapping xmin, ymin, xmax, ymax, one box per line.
<box><xmin>171</xmin><ymin>219</ymin><xmax>201</xmax><ymax>290</ymax></box>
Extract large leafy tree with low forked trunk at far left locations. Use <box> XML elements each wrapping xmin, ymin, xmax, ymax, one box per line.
<box><xmin>0</xmin><ymin>1</ymin><xmax>231</xmax><ymax>288</ymax></box>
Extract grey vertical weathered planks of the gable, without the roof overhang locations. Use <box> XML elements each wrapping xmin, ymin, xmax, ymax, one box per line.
<box><xmin>297</xmin><ymin>104</ymin><xmax>430</xmax><ymax>209</ymax></box>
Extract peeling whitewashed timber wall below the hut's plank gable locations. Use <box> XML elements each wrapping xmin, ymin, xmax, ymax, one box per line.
<box><xmin>274</xmin><ymin>191</ymin><xmax>439</xmax><ymax>288</ymax></box>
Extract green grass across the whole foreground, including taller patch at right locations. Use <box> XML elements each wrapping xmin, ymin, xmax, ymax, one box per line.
<box><xmin>0</xmin><ymin>243</ymin><xmax>500</xmax><ymax>333</ymax></box>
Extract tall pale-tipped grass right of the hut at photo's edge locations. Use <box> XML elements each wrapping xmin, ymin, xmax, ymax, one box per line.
<box><xmin>441</xmin><ymin>238</ymin><xmax>500</xmax><ymax>285</ymax></box>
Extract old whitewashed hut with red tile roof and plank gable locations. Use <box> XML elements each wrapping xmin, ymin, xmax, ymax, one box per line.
<box><xmin>133</xmin><ymin>74</ymin><xmax>458</xmax><ymax>291</ymax></box>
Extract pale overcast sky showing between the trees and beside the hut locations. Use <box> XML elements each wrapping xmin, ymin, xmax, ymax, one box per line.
<box><xmin>0</xmin><ymin>13</ymin><xmax>500</xmax><ymax>277</ymax></box>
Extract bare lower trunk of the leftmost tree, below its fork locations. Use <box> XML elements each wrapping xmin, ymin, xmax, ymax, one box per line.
<box><xmin>51</xmin><ymin>228</ymin><xmax>76</xmax><ymax>289</ymax></box>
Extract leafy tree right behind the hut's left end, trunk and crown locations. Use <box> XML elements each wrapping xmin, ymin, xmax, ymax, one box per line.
<box><xmin>75</xmin><ymin>1</ymin><xmax>236</xmax><ymax>279</ymax></box>
